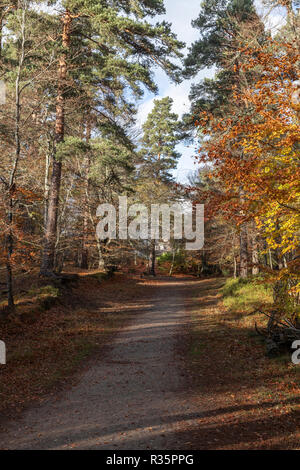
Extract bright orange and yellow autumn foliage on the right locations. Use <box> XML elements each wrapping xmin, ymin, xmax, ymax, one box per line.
<box><xmin>196</xmin><ymin>35</ymin><xmax>300</xmax><ymax>298</ymax></box>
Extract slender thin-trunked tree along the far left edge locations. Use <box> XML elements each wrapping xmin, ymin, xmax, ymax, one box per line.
<box><xmin>0</xmin><ymin>0</ymin><xmax>53</xmax><ymax>310</ymax></box>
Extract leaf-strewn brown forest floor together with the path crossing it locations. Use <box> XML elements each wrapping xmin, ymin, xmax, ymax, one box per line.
<box><xmin>0</xmin><ymin>275</ymin><xmax>300</xmax><ymax>450</ymax></box>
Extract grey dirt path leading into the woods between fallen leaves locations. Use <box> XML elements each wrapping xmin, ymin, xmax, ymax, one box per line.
<box><xmin>1</xmin><ymin>278</ymin><xmax>203</xmax><ymax>450</ymax></box>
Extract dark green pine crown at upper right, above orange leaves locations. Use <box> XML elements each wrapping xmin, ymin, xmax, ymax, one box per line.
<box><xmin>185</xmin><ymin>0</ymin><xmax>264</xmax><ymax>121</ymax></box>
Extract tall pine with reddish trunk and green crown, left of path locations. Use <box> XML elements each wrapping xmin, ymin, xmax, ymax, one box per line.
<box><xmin>41</xmin><ymin>0</ymin><xmax>183</xmax><ymax>275</ymax></box>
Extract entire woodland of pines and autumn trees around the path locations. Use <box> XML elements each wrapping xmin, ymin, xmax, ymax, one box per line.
<box><xmin>0</xmin><ymin>0</ymin><xmax>300</xmax><ymax>316</ymax></box>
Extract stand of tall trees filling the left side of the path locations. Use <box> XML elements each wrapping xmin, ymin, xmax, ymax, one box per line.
<box><xmin>0</xmin><ymin>0</ymin><xmax>183</xmax><ymax>308</ymax></box>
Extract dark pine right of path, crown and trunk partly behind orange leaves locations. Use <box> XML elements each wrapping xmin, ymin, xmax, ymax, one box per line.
<box><xmin>185</xmin><ymin>0</ymin><xmax>266</xmax><ymax>278</ymax></box>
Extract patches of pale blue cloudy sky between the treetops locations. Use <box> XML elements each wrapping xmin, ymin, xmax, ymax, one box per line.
<box><xmin>138</xmin><ymin>0</ymin><xmax>284</xmax><ymax>183</ymax></box>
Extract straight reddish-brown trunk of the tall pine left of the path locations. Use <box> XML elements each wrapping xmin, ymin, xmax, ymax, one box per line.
<box><xmin>41</xmin><ymin>11</ymin><xmax>72</xmax><ymax>275</ymax></box>
